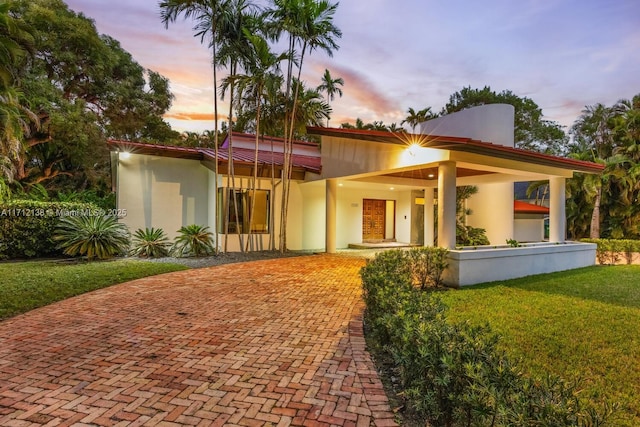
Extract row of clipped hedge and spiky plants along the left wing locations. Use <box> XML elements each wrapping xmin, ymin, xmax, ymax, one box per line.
<box><xmin>0</xmin><ymin>200</ymin><xmax>215</xmax><ymax>259</ymax></box>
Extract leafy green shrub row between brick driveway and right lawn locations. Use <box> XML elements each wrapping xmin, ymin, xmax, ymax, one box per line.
<box><xmin>361</xmin><ymin>251</ymin><xmax>610</xmax><ymax>426</ymax></box>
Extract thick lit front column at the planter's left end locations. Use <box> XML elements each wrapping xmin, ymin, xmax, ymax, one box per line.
<box><xmin>438</xmin><ymin>161</ymin><xmax>456</xmax><ymax>249</ymax></box>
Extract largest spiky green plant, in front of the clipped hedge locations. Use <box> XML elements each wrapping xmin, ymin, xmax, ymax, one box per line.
<box><xmin>53</xmin><ymin>215</ymin><xmax>130</xmax><ymax>260</ymax></box>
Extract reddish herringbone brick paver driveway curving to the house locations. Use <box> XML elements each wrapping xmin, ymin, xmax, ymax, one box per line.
<box><xmin>0</xmin><ymin>255</ymin><xmax>394</xmax><ymax>426</ymax></box>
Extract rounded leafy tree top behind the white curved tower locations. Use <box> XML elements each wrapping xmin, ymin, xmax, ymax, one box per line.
<box><xmin>441</xmin><ymin>86</ymin><xmax>568</xmax><ymax>155</ymax></box>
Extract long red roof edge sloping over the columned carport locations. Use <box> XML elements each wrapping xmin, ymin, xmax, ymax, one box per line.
<box><xmin>307</xmin><ymin>127</ymin><xmax>604</xmax><ymax>174</ymax></box>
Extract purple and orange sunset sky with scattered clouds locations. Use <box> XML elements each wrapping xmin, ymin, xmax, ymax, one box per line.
<box><xmin>66</xmin><ymin>0</ymin><xmax>640</xmax><ymax>132</ymax></box>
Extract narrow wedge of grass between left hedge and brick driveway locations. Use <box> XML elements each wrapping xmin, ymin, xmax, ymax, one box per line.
<box><xmin>0</xmin><ymin>259</ymin><xmax>186</xmax><ymax>319</ymax></box>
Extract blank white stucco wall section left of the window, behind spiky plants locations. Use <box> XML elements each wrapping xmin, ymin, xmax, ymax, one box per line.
<box><xmin>117</xmin><ymin>154</ymin><xmax>210</xmax><ymax>238</ymax></box>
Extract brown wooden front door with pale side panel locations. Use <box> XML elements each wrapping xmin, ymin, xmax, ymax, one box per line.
<box><xmin>362</xmin><ymin>199</ymin><xmax>396</xmax><ymax>243</ymax></box>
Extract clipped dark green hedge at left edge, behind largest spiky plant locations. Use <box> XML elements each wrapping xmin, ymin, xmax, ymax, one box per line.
<box><xmin>0</xmin><ymin>200</ymin><xmax>104</xmax><ymax>259</ymax></box>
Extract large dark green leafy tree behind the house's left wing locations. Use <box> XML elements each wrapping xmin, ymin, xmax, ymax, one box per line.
<box><xmin>12</xmin><ymin>0</ymin><xmax>178</xmax><ymax>192</ymax></box>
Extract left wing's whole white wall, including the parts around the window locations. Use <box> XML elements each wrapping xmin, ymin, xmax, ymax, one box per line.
<box><xmin>116</xmin><ymin>154</ymin><xmax>308</xmax><ymax>252</ymax></box>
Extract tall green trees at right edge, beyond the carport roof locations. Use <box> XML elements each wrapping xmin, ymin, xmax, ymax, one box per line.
<box><xmin>567</xmin><ymin>95</ymin><xmax>640</xmax><ymax>238</ymax></box>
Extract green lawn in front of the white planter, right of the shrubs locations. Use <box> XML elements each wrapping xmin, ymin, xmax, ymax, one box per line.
<box><xmin>443</xmin><ymin>266</ymin><xmax>640</xmax><ymax>426</ymax></box>
